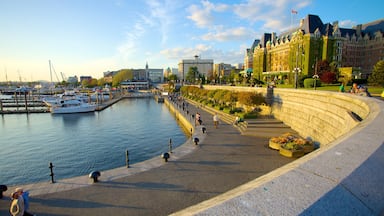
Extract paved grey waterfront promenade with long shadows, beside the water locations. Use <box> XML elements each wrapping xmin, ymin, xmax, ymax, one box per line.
<box><xmin>0</xmin><ymin>98</ymin><xmax>293</xmax><ymax>216</ymax></box>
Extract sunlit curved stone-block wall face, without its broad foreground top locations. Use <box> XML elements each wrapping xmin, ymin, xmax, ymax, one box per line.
<box><xmin>204</xmin><ymin>86</ymin><xmax>370</xmax><ymax>146</ymax></box>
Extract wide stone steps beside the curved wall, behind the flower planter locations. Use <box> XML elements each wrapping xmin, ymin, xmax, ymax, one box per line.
<box><xmin>237</xmin><ymin>117</ymin><xmax>297</xmax><ymax>138</ymax></box>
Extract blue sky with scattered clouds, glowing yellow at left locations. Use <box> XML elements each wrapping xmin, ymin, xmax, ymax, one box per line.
<box><xmin>0</xmin><ymin>0</ymin><xmax>384</xmax><ymax>81</ymax></box>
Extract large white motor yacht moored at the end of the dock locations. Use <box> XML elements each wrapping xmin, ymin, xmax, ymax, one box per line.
<box><xmin>49</xmin><ymin>99</ymin><xmax>97</xmax><ymax>114</ymax></box>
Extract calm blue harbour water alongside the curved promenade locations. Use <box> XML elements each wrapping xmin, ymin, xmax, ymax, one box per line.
<box><xmin>0</xmin><ymin>99</ymin><xmax>187</xmax><ymax>185</ymax></box>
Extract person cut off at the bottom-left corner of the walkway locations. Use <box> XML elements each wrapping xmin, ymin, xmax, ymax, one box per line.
<box><xmin>9</xmin><ymin>188</ymin><xmax>33</xmax><ymax>216</ymax></box>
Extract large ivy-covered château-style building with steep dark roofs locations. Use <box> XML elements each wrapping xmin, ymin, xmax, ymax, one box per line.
<box><xmin>249</xmin><ymin>15</ymin><xmax>384</xmax><ymax>83</ymax></box>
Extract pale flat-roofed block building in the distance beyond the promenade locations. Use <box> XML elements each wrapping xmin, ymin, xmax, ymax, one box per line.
<box><xmin>178</xmin><ymin>55</ymin><xmax>213</xmax><ymax>83</ymax></box>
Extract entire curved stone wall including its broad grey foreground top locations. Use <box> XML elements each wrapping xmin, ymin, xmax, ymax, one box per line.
<box><xmin>173</xmin><ymin>86</ymin><xmax>384</xmax><ymax>215</ymax></box>
